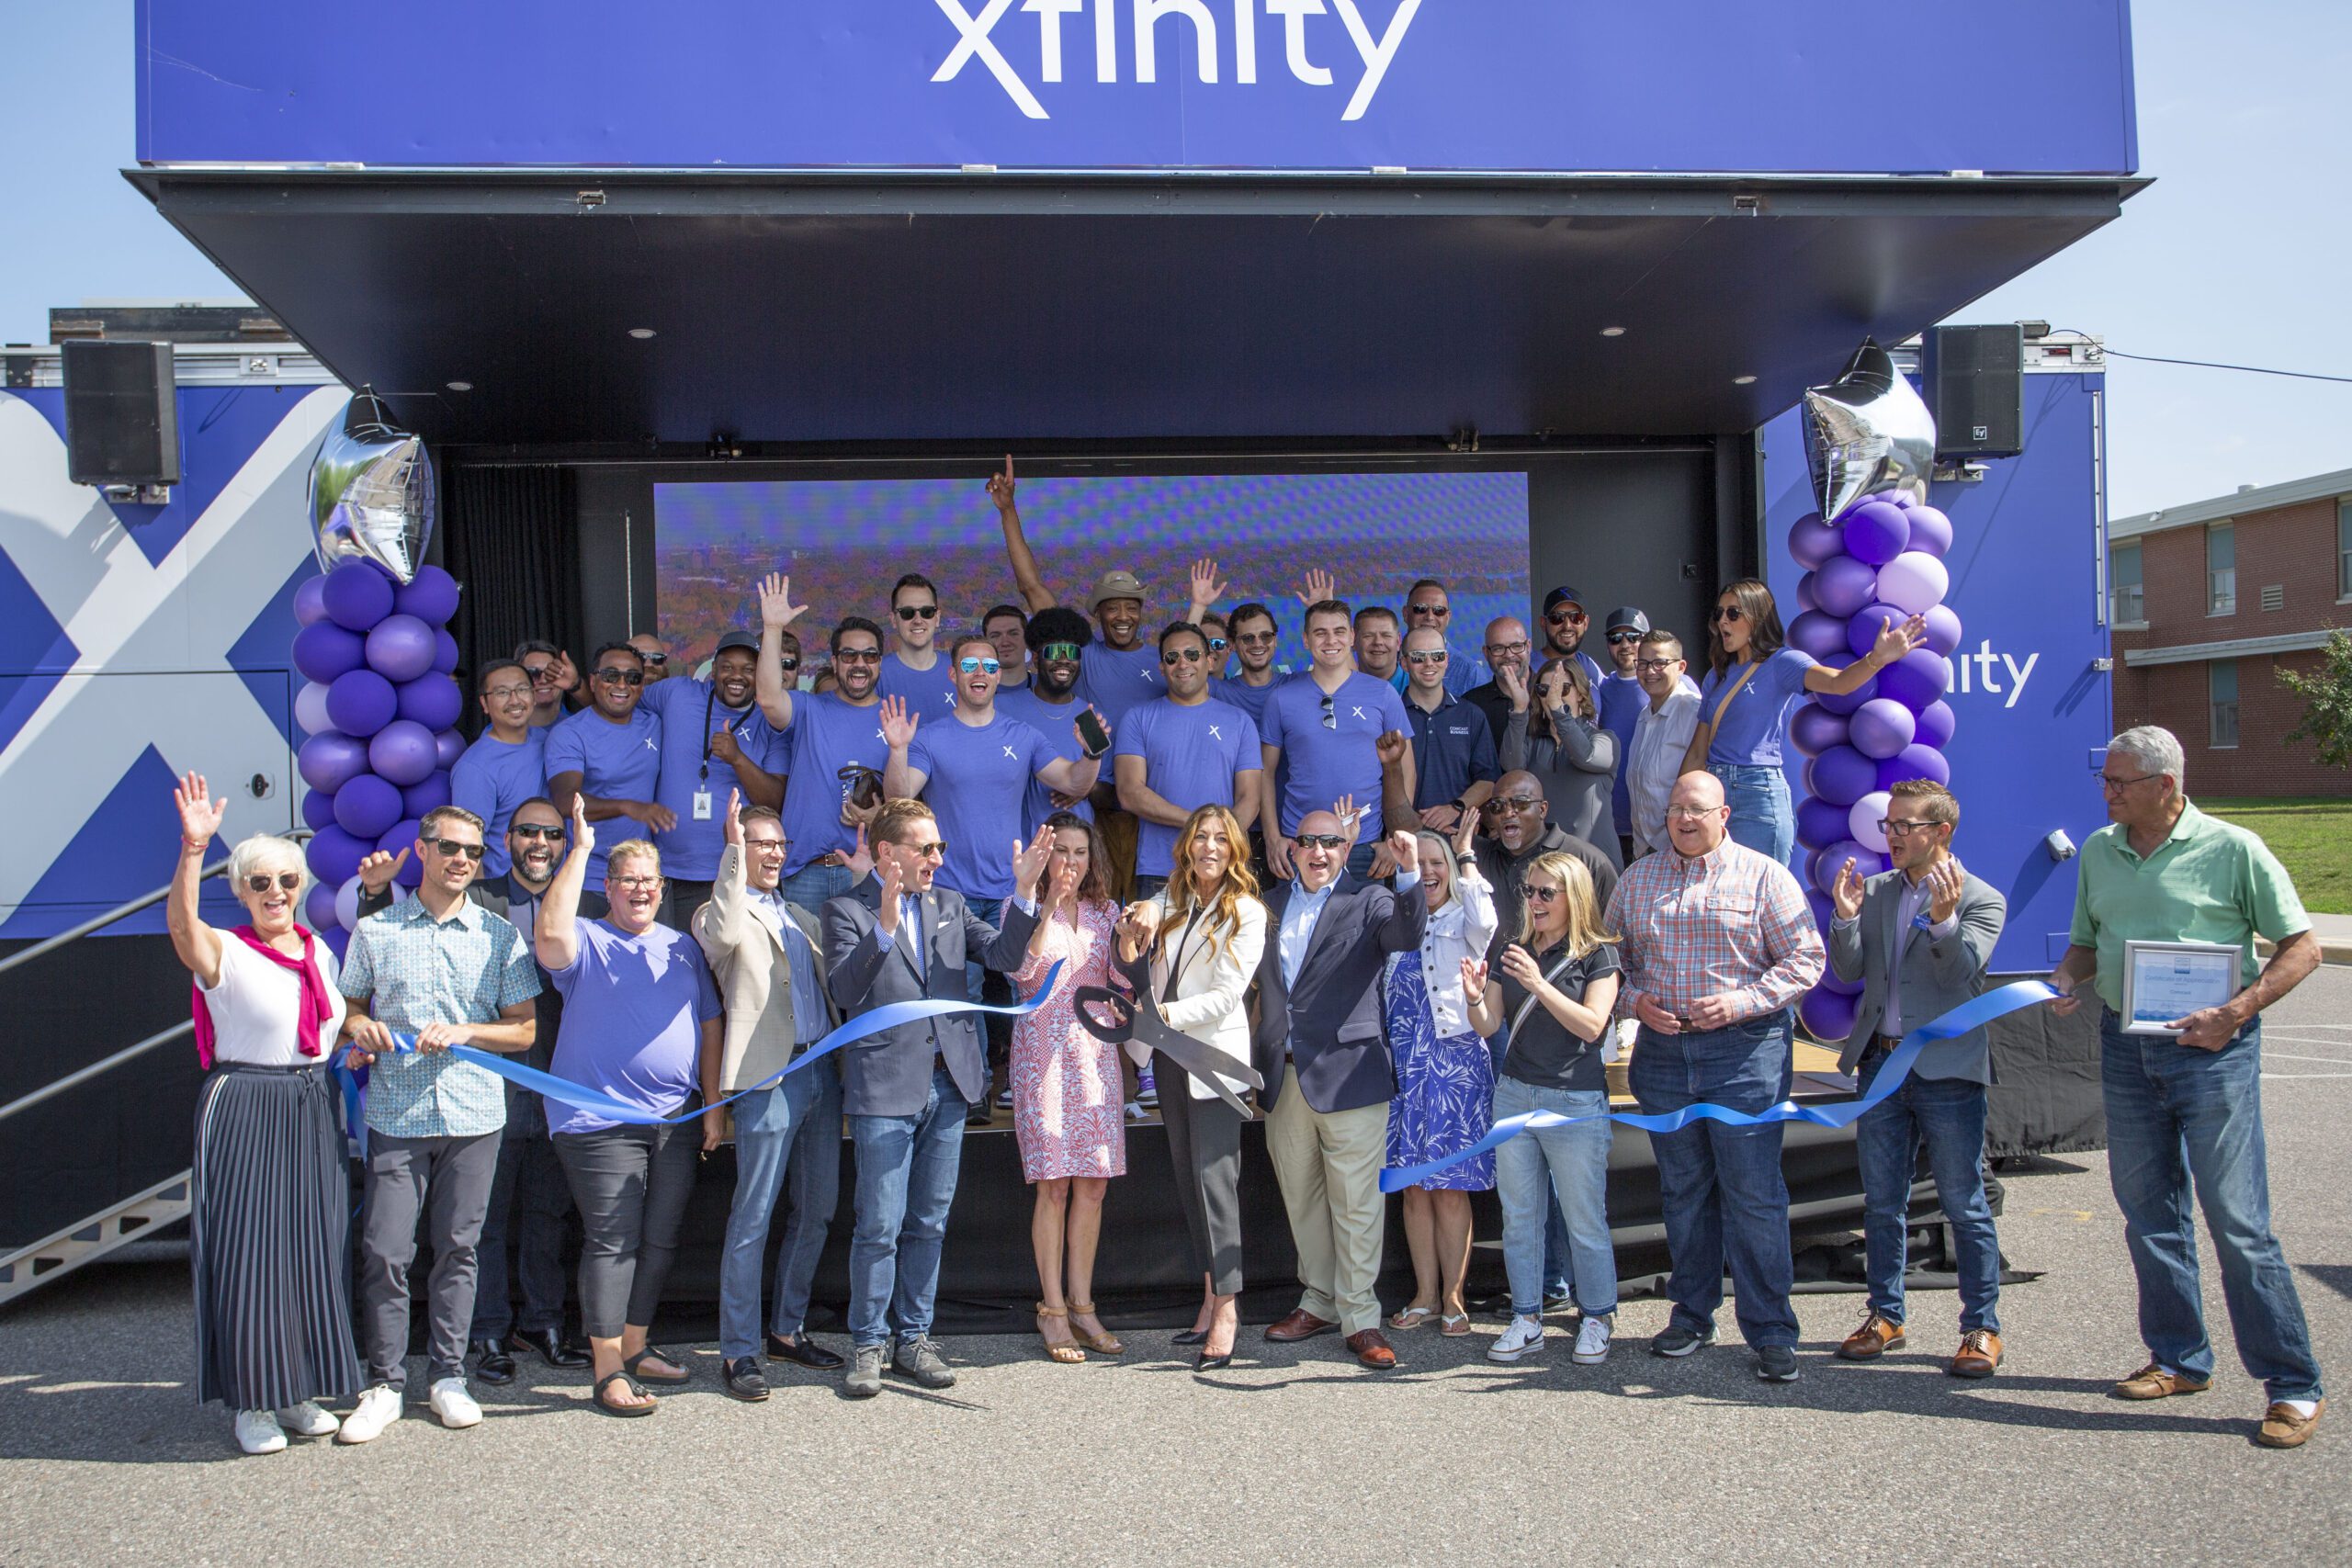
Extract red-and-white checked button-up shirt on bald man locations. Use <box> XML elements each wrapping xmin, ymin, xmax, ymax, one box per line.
<box><xmin>1601</xmin><ymin>840</ymin><xmax>1826</xmax><ymax>1021</ymax></box>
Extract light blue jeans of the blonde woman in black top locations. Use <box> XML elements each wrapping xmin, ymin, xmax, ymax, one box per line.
<box><xmin>1494</xmin><ymin>1079</ymin><xmax>1616</xmax><ymax>1316</ymax></box>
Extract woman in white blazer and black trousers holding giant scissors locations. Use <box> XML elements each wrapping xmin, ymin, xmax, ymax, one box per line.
<box><xmin>1117</xmin><ymin>807</ymin><xmax>1265</xmax><ymax>1368</ymax></box>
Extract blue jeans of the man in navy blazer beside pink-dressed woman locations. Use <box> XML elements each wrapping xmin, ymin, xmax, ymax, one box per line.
<box><xmin>849</xmin><ymin>1063</ymin><xmax>967</xmax><ymax>1349</ymax></box>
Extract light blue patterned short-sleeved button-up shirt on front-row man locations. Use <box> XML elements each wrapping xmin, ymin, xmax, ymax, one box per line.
<box><xmin>341</xmin><ymin>898</ymin><xmax>538</xmax><ymax>1138</ymax></box>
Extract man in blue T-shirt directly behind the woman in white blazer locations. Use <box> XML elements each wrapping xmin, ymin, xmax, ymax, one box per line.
<box><xmin>1113</xmin><ymin>623</ymin><xmax>1263</xmax><ymax>898</ymax></box>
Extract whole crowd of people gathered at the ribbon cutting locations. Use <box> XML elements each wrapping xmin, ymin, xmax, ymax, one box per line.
<box><xmin>172</xmin><ymin>463</ymin><xmax>2322</xmax><ymax>1450</ymax></box>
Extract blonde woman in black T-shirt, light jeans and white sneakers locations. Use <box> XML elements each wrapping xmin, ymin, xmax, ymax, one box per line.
<box><xmin>1461</xmin><ymin>851</ymin><xmax>1621</xmax><ymax>1366</ymax></box>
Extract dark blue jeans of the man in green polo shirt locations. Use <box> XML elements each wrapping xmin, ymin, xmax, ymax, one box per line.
<box><xmin>2098</xmin><ymin>1010</ymin><xmax>2319</xmax><ymax>1399</ymax></box>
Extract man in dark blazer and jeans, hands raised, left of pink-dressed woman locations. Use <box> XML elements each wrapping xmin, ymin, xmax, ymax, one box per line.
<box><xmin>823</xmin><ymin>799</ymin><xmax>1054</xmax><ymax>1399</ymax></box>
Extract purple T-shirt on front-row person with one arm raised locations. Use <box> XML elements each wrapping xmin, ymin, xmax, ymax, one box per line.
<box><xmin>546</xmin><ymin>919</ymin><xmax>719</xmax><ymax>1134</ymax></box>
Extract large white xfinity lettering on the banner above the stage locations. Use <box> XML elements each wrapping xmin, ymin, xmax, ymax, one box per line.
<box><xmin>932</xmin><ymin>0</ymin><xmax>1420</xmax><ymax>120</ymax></box>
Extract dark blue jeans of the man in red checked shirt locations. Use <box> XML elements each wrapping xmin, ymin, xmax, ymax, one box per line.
<box><xmin>1628</xmin><ymin>1009</ymin><xmax>1797</xmax><ymax>1349</ymax></box>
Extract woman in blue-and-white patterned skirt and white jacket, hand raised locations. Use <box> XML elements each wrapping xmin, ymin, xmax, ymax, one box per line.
<box><xmin>1381</xmin><ymin>811</ymin><xmax>1496</xmax><ymax>1336</ymax></box>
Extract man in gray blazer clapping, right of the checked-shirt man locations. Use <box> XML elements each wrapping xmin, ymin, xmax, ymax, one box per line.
<box><xmin>1830</xmin><ymin>778</ymin><xmax>2008</xmax><ymax>1378</ymax></box>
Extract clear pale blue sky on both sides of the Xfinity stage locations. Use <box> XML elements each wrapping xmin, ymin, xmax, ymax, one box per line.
<box><xmin>0</xmin><ymin>0</ymin><xmax>2352</xmax><ymax>517</ymax></box>
